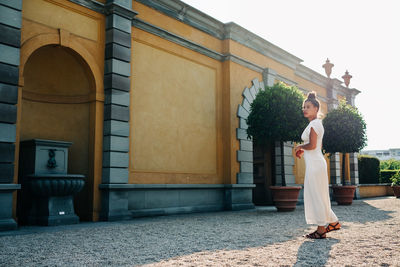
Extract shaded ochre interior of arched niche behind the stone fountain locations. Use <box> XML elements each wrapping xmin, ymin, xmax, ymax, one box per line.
<box><xmin>19</xmin><ymin>45</ymin><xmax>96</xmax><ymax>220</ymax></box>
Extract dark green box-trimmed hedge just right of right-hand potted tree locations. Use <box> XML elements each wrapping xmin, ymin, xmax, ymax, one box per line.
<box><xmin>358</xmin><ymin>155</ymin><xmax>380</xmax><ymax>184</ymax></box>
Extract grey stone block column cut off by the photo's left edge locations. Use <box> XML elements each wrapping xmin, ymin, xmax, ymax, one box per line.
<box><xmin>0</xmin><ymin>0</ymin><xmax>22</xmax><ymax>230</ymax></box>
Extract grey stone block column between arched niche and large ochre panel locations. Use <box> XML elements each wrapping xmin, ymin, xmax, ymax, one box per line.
<box><xmin>100</xmin><ymin>0</ymin><xmax>137</xmax><ymax>220</ymax></box>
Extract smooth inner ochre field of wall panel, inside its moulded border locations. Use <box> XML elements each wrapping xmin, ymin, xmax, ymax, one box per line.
<box><xmin>131</xmin><ymin>42</ymin><xmax>217</xmax><ymax>174</ymax></box>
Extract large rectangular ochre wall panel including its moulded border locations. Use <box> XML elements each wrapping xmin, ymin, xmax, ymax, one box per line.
<box><xmin>130</xmin><ymin>29</ymin><xmax>223</xmax><ymax>183</ymax></box>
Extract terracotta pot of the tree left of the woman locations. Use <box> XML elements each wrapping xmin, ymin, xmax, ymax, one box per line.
<box><xmin>269</xmin><ymin>186</ymin><xmax>301</xmax><ymax>211</ymax></box>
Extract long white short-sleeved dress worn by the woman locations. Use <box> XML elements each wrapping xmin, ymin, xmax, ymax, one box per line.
<box><xmin>301</xmin><ymin>119</ymin><xmax>338</xmax><ymax>226</ymax></box>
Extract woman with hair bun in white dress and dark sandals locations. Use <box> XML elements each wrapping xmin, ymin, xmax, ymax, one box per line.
<box><xmin>295</xmin><ymin>92</ymin><xmax>341</xmax><ymax>239</ymax></box>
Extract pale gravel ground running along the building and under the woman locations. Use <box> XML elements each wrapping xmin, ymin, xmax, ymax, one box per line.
<box><xmin>0</xmin><ymin>197</ymin><xmax>400</xmax><ymax>266</ymax></box>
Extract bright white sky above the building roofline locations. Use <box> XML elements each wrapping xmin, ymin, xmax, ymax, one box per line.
<box><xmin>184</xmin><ymin>0</ymin><xmax>400</xmax><ymax>149</ymax></box>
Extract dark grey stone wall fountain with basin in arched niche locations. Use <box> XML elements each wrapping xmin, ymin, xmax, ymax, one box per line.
<box><xmin>18</xmin><ymin>139</ymin><xmax>85</xmax><ymax>225</ymax></box>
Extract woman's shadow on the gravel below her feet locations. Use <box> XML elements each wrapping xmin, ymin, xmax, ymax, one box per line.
<box><xmin>294</xmin><ymin>238</ymin><xmax>339</xmax><ymax>266</ymax></box>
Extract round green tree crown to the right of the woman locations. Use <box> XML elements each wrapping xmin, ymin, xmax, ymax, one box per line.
<box><xmin>322</xmin><ymin>101</ymin><xmax>367</xmax><ymax>153</ymax></box>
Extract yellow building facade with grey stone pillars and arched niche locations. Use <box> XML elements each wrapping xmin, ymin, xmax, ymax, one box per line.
<box><xmin>0</xmin><ymin>0</ymin><xmax>359</xmax><ymax>230</ymax></box>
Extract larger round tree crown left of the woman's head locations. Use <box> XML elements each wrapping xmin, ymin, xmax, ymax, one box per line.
<box><xmin>247</xmin><ymin>82</ymin><xmax>307</xmax><ymax>148</ymax></box>
